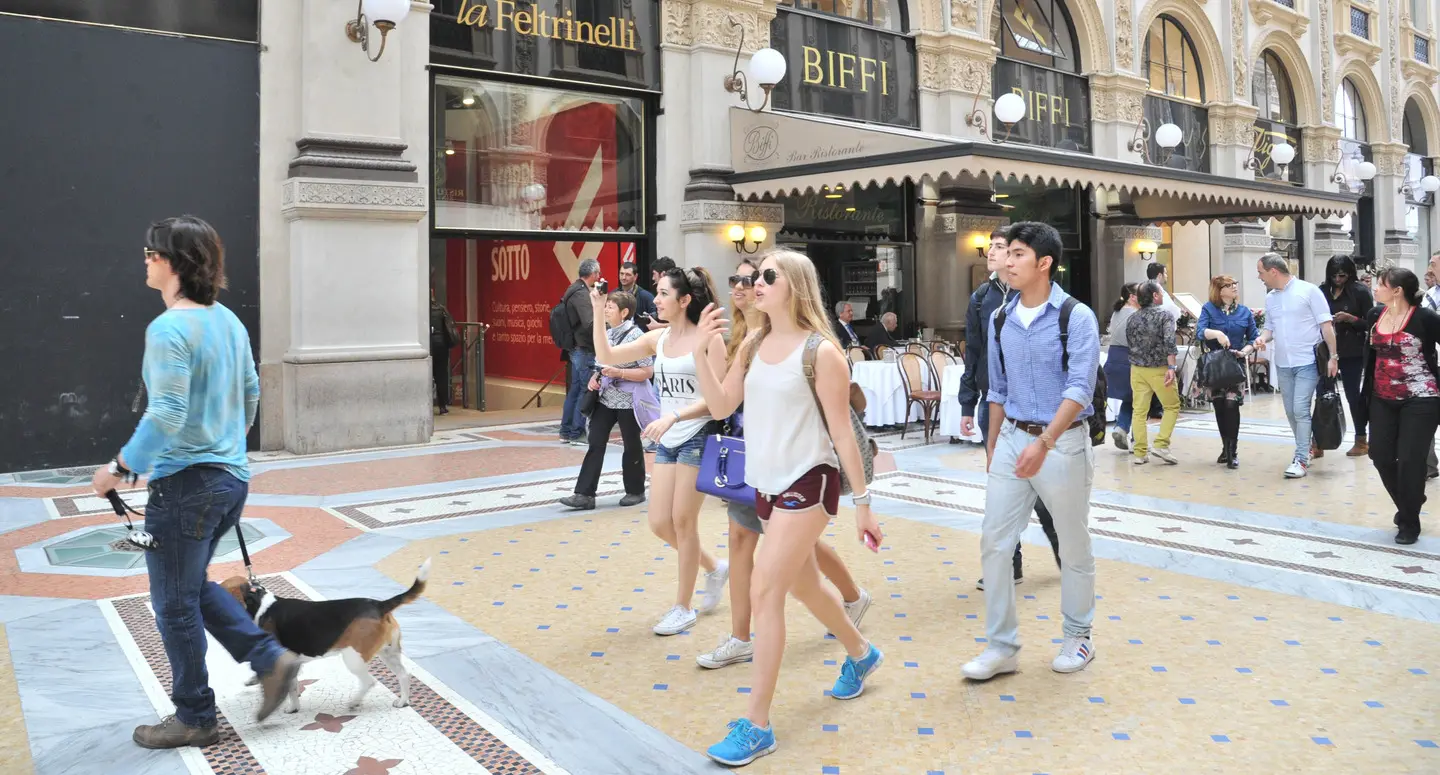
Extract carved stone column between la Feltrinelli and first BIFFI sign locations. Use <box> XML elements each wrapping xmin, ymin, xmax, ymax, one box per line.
<box><xmin>655</xmin><ymin>0</ymin><xmax>777</xmax><ymax>260</ymax></box>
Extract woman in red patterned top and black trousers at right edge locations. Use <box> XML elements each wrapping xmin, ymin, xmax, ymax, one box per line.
<box><xmin>1364</xmin><ymin>268</ymin><xmax>1440</xmax><ymax>546</ymax></box>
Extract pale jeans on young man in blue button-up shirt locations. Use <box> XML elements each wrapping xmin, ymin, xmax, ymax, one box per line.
<box><xmin>981</xmin><ymin>421</ymin><xmax>1094</xmax><ymax>654</ymax></box>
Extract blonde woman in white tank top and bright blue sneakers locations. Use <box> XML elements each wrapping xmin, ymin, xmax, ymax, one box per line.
<box><xmin>698</xmin><ymin>251</ymin><xmax>884</xmax><ymax>766</ymax></box>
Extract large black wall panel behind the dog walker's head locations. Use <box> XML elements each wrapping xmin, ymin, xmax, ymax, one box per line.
<box><xmin>0</xmin><ymin>16</ymin><xmax>259</xmax><ymax>471</ymax></box>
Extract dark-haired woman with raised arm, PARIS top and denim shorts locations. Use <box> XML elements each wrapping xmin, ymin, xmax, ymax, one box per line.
<box><xmin>590</xmin><ymin>266</ymin><xmax>729</xmax><ymax>635</ymax></box>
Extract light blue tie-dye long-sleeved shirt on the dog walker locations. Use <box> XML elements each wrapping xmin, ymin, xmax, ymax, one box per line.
<box><xmin>121</xmin><ymin>304</ymin><xmax>261</xmax><ymax>481</ymax></box>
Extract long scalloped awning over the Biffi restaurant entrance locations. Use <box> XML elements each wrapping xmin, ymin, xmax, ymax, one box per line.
<box><xmin>729</xmin><ymin>108</ymin><xmax>1359</xmax><ymax>223</ymax></box>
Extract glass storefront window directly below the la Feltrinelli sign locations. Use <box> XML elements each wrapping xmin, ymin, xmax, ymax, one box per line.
<box><xmin>433</xmin><ymin>75</ymin><xmax>645</xmax><ymax>233</ymax></box>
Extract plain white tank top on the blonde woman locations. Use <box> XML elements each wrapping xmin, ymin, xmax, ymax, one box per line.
<box><xmin>744</xmin><ymin>341</ymin><xmax>840</xmax><ymax>496</ymax></box>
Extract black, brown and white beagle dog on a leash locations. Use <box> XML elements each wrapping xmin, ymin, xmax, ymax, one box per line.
<box><xmin>220</xmin><ymin>559</ymin><xmax>431</xmax><ymax>713</ymax></box>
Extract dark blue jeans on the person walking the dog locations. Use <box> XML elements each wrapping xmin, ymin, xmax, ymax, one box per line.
<box><xmin>145</xmin><ymin>465</ymin><xmax>284</xmax><ymax>726</ymax></box>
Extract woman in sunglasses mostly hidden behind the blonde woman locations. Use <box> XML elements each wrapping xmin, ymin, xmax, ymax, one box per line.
<box><xmin>696</xmin><ymin>259</ymin><xmax>870</xmax><ymax>670</ymax></box>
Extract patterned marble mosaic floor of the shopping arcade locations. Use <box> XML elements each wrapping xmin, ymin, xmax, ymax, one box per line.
<box><xmin>0</xmin><ymin>396</ymin><xmax>1440</xmax><ymax>775</ymax></box>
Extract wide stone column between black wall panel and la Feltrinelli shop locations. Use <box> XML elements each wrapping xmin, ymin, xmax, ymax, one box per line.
<box><xmin>259</xmin><ymin>0</ymin><xmax>433</xmax><ymax>454</ymax></box>
